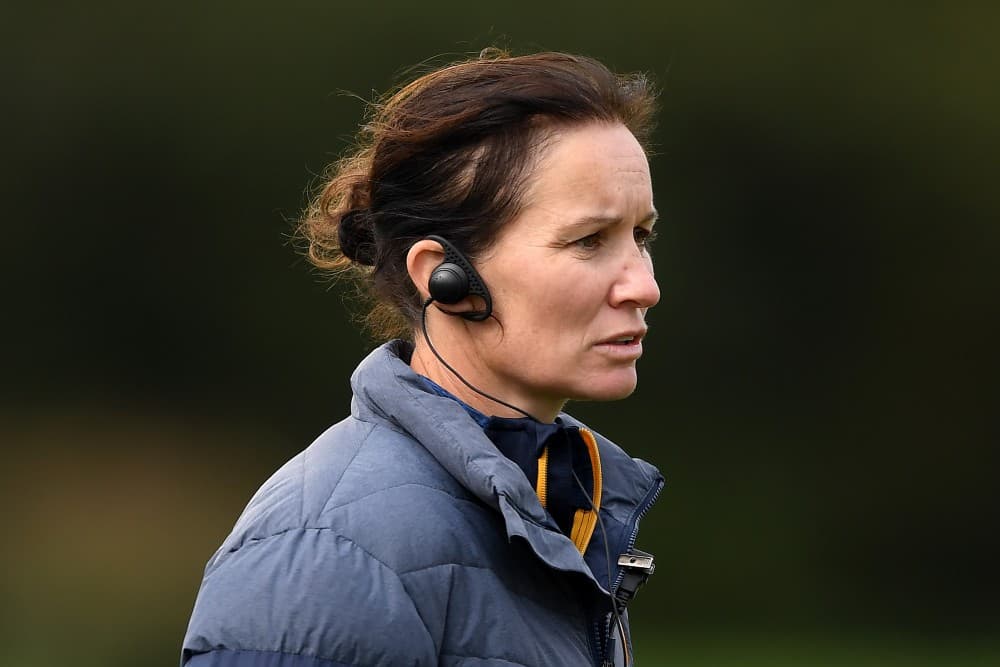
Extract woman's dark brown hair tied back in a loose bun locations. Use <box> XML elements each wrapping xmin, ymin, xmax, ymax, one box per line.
<box><xmin>299</xmin><ymin>49</ymin><xmax>655</xmax><ymax>339</ymax></box>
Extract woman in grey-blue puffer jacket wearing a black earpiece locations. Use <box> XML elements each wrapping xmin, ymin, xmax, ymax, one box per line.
<box><xmin>182</xmin><ymin>53</ymin><xmax>663</xmax><ymax>667</ymax></box>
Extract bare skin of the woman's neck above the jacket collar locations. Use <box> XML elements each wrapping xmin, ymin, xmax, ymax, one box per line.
<box><xmin>410</xmin><ymin>336</ymin><xmax>562</xmax><ymax>423</ymax></box>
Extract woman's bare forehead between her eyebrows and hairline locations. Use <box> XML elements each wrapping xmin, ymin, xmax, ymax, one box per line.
<box><xmin>524</xmin><ymin>123</ymin><xmax>653</xmax><ymax>218</ymax></box>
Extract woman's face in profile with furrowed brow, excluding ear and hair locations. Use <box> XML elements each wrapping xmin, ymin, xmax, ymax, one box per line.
<box><xmin>470</xmin><ymin>124</ymin><xmax>660</xmax><ymax>418</ymax></box>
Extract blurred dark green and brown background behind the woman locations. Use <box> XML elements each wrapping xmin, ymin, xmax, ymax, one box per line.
<box><xmin>0</xmin><ymin>0</ymin><xmax>1000</xmax><ymax>667</ymax></box>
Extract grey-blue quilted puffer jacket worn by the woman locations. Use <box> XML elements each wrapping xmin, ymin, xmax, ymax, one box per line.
<box><xmin>181</xmin><ymin>341</ymin><xmax>663</xmax><ymax>667</ymax></box>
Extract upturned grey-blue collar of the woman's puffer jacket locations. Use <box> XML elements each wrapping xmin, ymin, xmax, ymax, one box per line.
<box><xmin>351</xmin><ymin>340</ymin><xmax>663</xmax><ymax>594</ymax></box>
